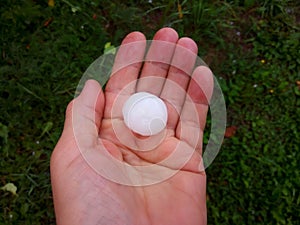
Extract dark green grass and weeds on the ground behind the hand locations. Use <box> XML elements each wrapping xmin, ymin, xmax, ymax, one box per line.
<box><xmin>0</xmin><ymin>0</ymin><xmax>300</xmax><ymax>224</ymax></box>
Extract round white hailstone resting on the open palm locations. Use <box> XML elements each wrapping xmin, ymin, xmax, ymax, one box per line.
<box><xmin>122</xmin><ymin>92</ymin><xmax>168</xmax><ymax>136</ymax></box>
